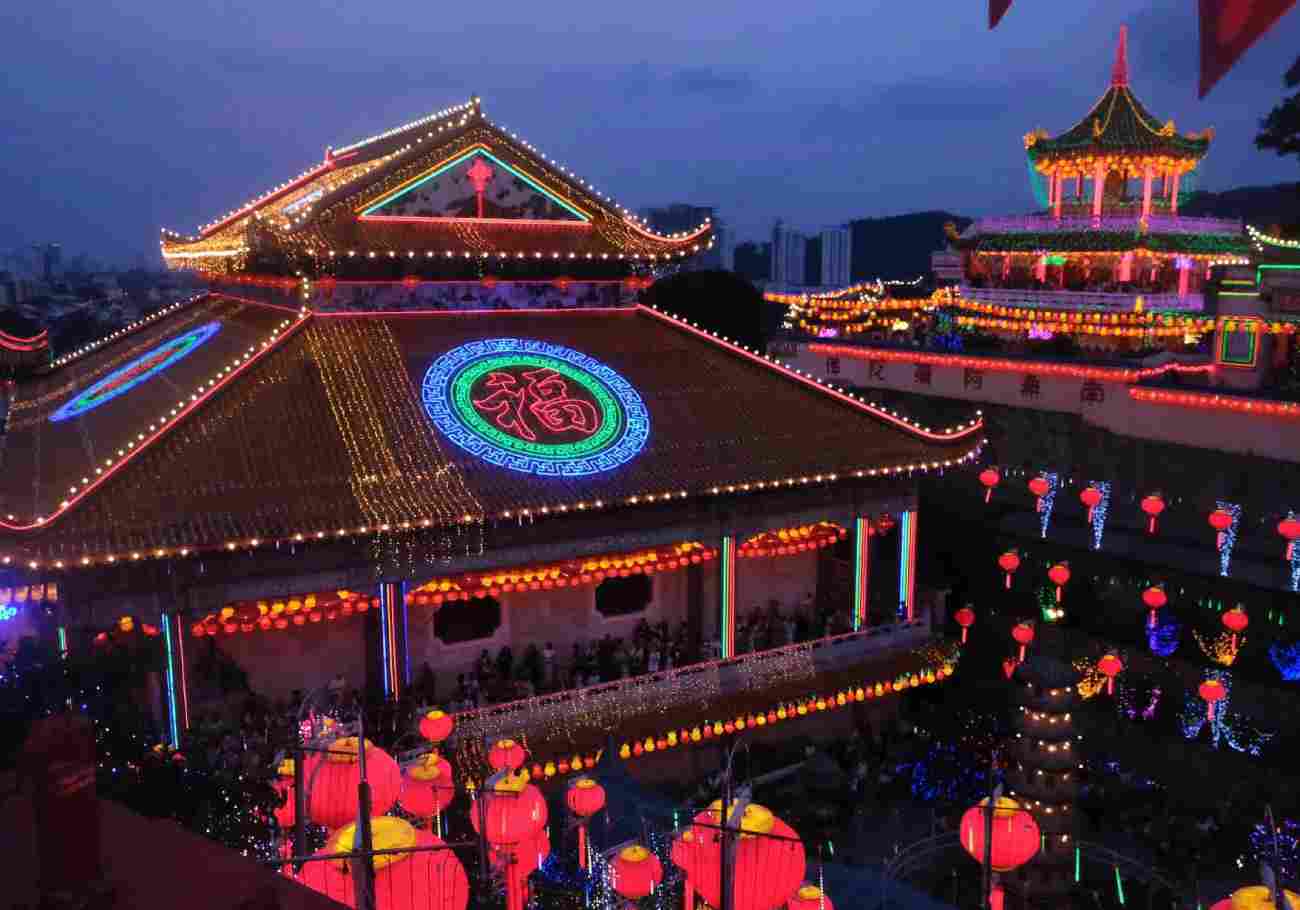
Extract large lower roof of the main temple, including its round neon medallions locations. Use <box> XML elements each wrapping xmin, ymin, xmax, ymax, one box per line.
<box><xmin>0</xmin><ymin>295</ymin><xmax>983</xmax><ymax>568</ymax></box>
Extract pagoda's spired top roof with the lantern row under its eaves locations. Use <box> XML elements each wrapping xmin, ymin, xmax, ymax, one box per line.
<box><xmin>1024</xmin><ymin>29</ymin><xmax>1214</xmax><ymax>174</ymax></box>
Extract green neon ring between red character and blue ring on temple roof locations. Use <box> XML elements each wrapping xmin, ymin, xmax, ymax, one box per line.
<box><xmin>451</xmin><ymin>354</ymin><xmax>624</xmax><ymax>459</ymax></box>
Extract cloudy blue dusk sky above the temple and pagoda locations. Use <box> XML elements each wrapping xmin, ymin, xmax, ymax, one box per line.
<box><xmin>0</xmin><ymin>0</ymin><xmax>1300</xmax><ymax>264</ymax></box>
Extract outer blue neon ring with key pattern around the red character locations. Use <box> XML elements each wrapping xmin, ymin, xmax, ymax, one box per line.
<box><xmin>420</xmin><ymin>338</ymin><xmax>650</xmax><ymax>477</ymax></box>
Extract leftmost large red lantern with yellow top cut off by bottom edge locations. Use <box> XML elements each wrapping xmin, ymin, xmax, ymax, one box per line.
<box><xmin>296</xmin><ymin>816</ymin><xmax>469</xmax><ymax>910</ymax></box>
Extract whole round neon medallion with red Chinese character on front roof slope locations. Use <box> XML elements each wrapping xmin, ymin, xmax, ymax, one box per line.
<box><xmin>421</xmin><ymin>338</ymin><xmax>650</xmax><ymax>477</ymax></box>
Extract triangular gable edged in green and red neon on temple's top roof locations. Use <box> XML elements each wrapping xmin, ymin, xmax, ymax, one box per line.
<box><xmin>358</xmin><ymin>143</ymin><xmax>592</xmax><ymax>224</ymax></box>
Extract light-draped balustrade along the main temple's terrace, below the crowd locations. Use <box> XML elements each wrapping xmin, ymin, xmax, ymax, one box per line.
<box><xmin>455</xmin><ymin>619</ymin><xmax>930</xmax><ymax>735</ymax></box>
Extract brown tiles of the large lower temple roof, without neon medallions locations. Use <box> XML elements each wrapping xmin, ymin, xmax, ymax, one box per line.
<box><xmin>0</xmin><ymin>299</ymin><xmax>980</xmax><ymax>566</ymax></box>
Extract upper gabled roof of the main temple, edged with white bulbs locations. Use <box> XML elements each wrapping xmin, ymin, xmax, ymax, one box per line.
<box><xmin>161</xmin><ymin>99</ymin><xmax>712</xmax><ymax>277</ymax></box>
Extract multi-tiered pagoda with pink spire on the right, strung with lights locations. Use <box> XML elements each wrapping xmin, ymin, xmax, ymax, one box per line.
<box><xmin>954</xmin><ymin>27</ymin><xmax>1247</xmax><ymax>319</ymax></box>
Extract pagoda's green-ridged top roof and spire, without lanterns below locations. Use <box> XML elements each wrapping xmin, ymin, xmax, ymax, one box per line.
<box><xmin>1024</xmin><ymin>27</ymin><xmax>1213</xmax><ymax>164</ymax></box>
